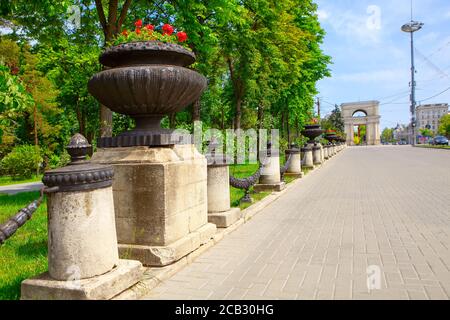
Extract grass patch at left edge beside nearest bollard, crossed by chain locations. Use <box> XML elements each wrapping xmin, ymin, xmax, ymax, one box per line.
<box><xmin>0</xmin><ymin>192</ymin><xmax>47</xmax><ymax>300</ymax></box>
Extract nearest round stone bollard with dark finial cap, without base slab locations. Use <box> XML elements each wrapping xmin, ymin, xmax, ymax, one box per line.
<box><xmin>43</xmin><ymin>135</ymin><xmax>119</xmax><ymax>280</ymax></box>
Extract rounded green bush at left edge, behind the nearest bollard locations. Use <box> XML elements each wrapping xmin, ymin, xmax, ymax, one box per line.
<box><xmin>0</xmin><ymin>145</ymin><xmax>42</xmax><ymax>178</ymax></box>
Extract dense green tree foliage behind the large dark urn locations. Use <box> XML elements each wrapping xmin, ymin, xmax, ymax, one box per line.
<box><xmin>0</xmin><ymin>0</ymin><xmax>330</xmax><ymax>175</ymax></box>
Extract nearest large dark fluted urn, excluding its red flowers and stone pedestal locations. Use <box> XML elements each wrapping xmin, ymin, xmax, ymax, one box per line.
<box><xmin>88</xmin><ymin>41</ymin><xmax>207</xmax><ymax>147</ymax></box>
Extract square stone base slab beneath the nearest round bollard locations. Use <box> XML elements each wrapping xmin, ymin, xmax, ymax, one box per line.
<box><xmin>21</xmin><ymin>260</ymin><xmax>143</xmax><ymax>300</ymax></box>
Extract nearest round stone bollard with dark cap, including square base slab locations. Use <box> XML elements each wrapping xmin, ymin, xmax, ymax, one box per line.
<box><xmin>22</xmin><ymin>134</ymin><xmax>142</xmax><ymax>299</ymax></box>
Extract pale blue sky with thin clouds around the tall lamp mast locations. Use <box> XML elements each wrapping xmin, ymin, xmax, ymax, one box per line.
<box><xmin>316</xmin><ymin>0</ymin><xmax>450</xmax><ymax>128</ymax></box>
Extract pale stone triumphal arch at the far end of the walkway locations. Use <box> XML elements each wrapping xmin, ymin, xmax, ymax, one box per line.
<box><xmin>341</xmin><ymin>101</ymin><xmax>381</xmax><ymax>145</ymax></box>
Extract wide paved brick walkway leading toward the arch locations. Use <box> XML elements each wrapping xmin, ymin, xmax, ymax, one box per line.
<box><xmin>143</xmin><ymin>146</ymin><xmax>450</xmax><ymax>299</ymax></box>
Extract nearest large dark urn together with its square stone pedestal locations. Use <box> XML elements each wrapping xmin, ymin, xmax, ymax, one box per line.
<box><xmin>88</xmin><ymin>41</ymin><xmax>216</xmax><ymax>266</ymax></box>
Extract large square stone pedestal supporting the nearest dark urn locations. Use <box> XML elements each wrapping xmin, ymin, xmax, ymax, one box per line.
<box><xmin>92</xmin><ymin>145</ymin><xmax>216</xmax><ymax>266</ymax></box>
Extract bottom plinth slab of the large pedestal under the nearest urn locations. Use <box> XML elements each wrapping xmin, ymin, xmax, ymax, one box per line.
<box><xmin>119</xmin><ymin>223</ymin><xmax>217</xmax><ymax>267</ymax></box>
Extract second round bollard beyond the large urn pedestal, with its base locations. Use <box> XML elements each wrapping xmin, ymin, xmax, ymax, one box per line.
<box><xmin>253</xmin><ymin>152</ymin><xmax>286</xmax><ymax>192</ymax></box>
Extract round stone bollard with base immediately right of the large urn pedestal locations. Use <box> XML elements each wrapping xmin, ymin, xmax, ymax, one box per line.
<box><xmin>208</xmin><ymin>163</ymin><xmax>241</xmax><ymax>228</ymax></box>
